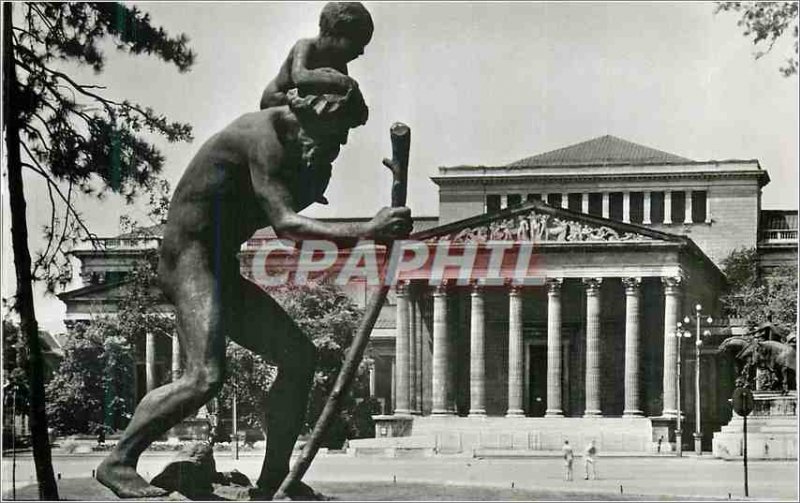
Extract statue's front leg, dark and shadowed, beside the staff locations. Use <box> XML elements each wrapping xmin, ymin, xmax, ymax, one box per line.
<box><xmin>231</xmin><ymin>278</ymin><xmax>316</xmax><ymax>497</ymax></box>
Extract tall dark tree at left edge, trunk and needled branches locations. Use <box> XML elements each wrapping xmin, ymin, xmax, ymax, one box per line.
<box><xmin>3</xmin><ymin>2</ymin><xmax>194</xmax><ymax>500</ymax></box>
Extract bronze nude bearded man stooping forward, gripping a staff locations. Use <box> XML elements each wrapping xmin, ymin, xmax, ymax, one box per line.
<box><xmin>97</xmin><ymin>88</ymin><xmax>412</xmax><ymax>499</ymax></box>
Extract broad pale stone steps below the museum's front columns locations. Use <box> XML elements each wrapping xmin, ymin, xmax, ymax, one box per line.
<box><xmin>348</xmin><ymin>416</ymin><xmax>656</xmax><ymax>457</ymax></box>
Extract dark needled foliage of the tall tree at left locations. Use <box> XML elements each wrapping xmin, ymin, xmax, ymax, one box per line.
<box><xmin>6</xmin><ymin>2</ymin><xmax>194</xmax><ymax>291</ymax></box>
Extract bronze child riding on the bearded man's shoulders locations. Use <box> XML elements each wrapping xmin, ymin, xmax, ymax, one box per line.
<box><xmin>261</xmin><ymin>2</ymin><xmax>374</xmax><ymax>110</ymax></box>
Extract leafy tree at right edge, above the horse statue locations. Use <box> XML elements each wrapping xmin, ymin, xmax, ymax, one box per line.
<box><xmin>721</xmin><ymin>248</ymin><xmax>797</xmax><ymax>331</ymax></box>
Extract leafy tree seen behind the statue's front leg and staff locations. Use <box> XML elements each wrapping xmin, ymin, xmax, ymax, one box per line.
<box><xmin>220</xmin><ymin>283</ymin><xmax>375</xmax><ymax>447</ymax></box>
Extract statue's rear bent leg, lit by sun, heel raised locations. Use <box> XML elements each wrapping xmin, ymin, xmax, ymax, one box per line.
<box><xmin>97</xmin><ymin>252</ymin><xmax>228</xmax><ymax>498</ymax></box>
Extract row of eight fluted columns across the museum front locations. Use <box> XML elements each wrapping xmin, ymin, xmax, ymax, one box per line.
<box><xmin>394</xmin><ymin>277</ymin><xmax>681</xmax><ymax>417</ymax></box>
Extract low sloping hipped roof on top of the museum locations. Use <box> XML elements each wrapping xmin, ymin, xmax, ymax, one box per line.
<box><xmin>509</xmin><ymin>135</ymin><xmax>693</xmax><ymax>167</ymax></box>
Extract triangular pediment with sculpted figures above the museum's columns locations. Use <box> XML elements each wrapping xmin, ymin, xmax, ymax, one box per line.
<box><xmin>411</xmin><ymin>201</ymin><xmax>686</xmax><ymax>244</ymax></box>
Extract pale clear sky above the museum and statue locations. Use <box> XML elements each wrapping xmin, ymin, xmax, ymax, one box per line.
<box><xmin>2</xmin><ymin>2</ymin><xmax>798</xmax><ymax>331</ymax></box>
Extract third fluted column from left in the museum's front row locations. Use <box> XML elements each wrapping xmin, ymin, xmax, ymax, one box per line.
<box><xmin>469</xmin><ymin>282</ymin><xmax>486</xmax><ymax>417</ymax></box>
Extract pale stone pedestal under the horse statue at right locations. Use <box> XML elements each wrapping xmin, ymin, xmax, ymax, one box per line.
<box><xmin>711</xmin><ymin>391</ymin><xmax>798</xmax><ymax>459</ymax></box>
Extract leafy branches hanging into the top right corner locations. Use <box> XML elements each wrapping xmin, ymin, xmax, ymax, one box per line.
<box><xmin>714</xmin><ymin>2</ymin><xmax>798</xmax><ymax>77</ymax></box>
